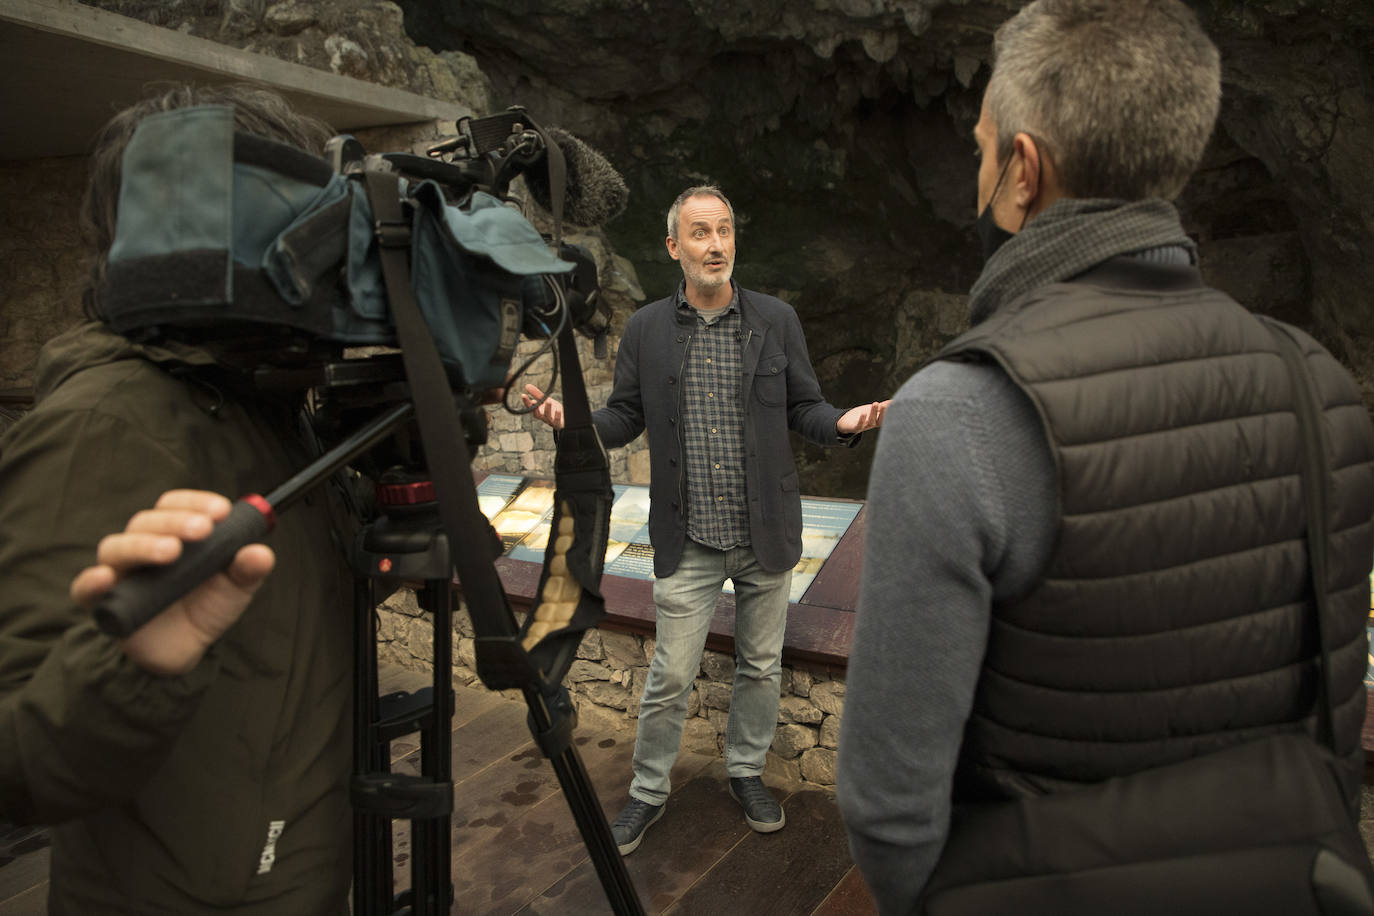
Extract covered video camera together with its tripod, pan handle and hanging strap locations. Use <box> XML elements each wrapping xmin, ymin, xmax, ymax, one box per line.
<box><xmin>95</xmin><ymin>106</ymin><xmax>642</xmax><ymax>916</ymax></box>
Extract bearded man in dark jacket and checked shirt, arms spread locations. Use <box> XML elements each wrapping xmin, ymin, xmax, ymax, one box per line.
<box><xmin>525</xmin><ymin>187</ymin><xmax>886</xmax><ymax>854</ymax></box>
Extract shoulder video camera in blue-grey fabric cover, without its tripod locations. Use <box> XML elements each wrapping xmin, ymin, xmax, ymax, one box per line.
<box><xmin>106</xmin><ymin>106</ymin><xmax>627</xmax><ymax>390</ymax></box>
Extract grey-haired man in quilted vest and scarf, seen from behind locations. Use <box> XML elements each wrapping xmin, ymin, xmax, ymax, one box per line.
<box><xmin>838</xmin><ymin>0</ymin><xmax>1374</xmax><ymax>913</ymax></box>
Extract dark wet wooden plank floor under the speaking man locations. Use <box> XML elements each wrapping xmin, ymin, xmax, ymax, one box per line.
<box><xmin>0</xmin><ymin>667</ymin><xmax>877</xmax><ymax>916</ymax></box>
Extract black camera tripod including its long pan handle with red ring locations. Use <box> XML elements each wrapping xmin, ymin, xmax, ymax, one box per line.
<box><xmin>93</xmin><ymin>402</ymin><xmax>643</xmax><ymax>916</ymax></box>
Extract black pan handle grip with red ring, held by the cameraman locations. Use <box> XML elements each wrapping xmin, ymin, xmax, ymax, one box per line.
<box><xmin>95</xmin><ymin>493</ymin><xmax>273</xmax><ymax>637</ymax></box>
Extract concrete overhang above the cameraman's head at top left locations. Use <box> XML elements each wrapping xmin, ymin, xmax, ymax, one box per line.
<box><xmin>0</xmin><ymin>0</ymin><xmax>471</xmax><ymax>159</ymax></box>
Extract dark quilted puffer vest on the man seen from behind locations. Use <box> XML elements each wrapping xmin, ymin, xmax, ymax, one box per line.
<box><xmin>940</xmin><ymin>258</ymin><xmax>1374</xmax><ymax>801</ymax></box>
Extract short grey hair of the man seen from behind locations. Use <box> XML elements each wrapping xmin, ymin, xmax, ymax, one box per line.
<box><xmin>985</xmin><ymin>0</ymin><xmax>1221</xmax><ymax>201</ymax></box>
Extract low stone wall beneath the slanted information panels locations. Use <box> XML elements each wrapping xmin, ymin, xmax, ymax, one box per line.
<box><xmin>378</xmin><ymin>589</ymin><xmax>845</xmax><ymax>787</ymax></box>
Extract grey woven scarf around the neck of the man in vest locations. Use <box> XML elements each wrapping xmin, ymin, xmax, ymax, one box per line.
<box><xmin>969</xmin><ymin>198</ymin><xmax>1197</xmax><ymax>325</ymax></box>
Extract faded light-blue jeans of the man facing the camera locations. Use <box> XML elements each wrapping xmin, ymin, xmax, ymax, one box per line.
<box><xmin>629</xmin><ymin>540</ymin><xmax>791</xmax><ymax>805</ymax></box>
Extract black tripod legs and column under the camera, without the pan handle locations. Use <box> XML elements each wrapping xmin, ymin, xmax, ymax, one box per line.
<box><xmin>343</xmin><ymin>474</ymin><xmax>643</xmax><ymax>916</ymax></box>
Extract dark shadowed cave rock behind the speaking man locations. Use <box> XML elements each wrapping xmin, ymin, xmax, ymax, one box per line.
<box><xmin>401</xmin><ymin>0</ymin><xmax>1374</xmax><ymax>489</ymax></box>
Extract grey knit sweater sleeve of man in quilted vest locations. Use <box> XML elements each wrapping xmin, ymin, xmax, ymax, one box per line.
<box><xmin>837</xmin><ymin>363</ymin><xmax>1055</xmax><ymax>916</ymax></box>
